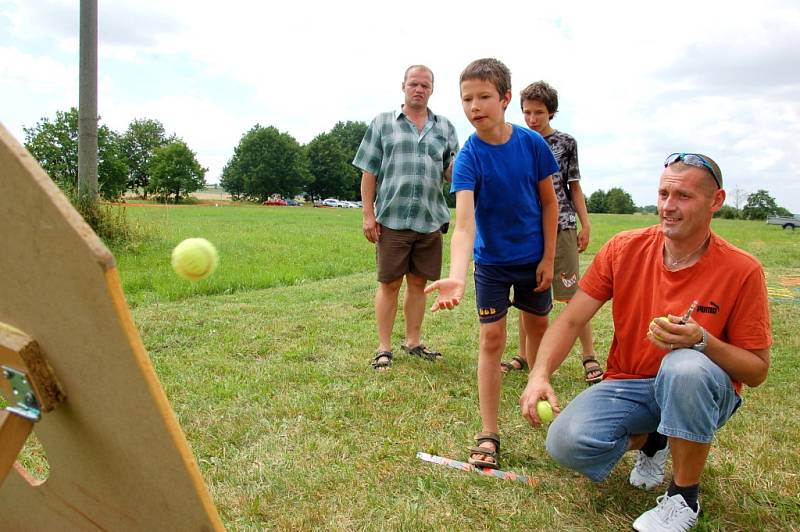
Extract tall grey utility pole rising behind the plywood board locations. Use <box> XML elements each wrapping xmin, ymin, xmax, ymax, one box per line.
<box><xmin>78</xmin><ymin>0</ymin><xmax>97</xmax><ymax>202</ymax></box>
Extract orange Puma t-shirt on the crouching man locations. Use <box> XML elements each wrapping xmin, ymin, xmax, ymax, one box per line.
<box><xmin>580</xmin><ymin>225</ymin><xmax>772</xmax><ymax>392</ymax></box>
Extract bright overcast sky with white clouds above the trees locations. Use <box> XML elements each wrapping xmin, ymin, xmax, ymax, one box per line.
<box><xmin>0</xmin><ymin>0</ymin><xmax>800</xmax><ymax>213</ymax></box>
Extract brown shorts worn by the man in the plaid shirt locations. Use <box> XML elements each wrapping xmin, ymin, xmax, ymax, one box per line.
<box><xmin>375</xmin><ymin>226</ymin><xmax>442</xmax><ymax>283</ymax></box>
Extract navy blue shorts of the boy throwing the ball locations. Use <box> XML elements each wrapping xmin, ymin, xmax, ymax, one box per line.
<box><xmin>475</xmin><ymin>263</ymin><xmax>553</xmax><ymax>323</ymax></box>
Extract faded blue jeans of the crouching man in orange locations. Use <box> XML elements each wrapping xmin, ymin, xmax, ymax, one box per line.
<box><xmin>545</xmin><ymin>349</ymin><xmax>741</xmax><ymax>482</ymax></box>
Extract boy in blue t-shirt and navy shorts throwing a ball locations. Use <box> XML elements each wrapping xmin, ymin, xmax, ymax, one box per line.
<box><xmin>425</xmin><ymin>59</ymin><xmax>559</xmax><ymax>468</ymax></box>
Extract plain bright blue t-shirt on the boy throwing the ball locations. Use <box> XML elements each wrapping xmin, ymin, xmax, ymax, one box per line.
<box><xmin>450</xmin><ymin>126</ymin><xmax>558</xmax><ymax>266</ymax></box>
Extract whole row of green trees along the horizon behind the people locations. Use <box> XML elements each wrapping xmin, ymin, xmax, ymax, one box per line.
<box><xmin>24</xmin><ymin>107</ymin><xmax>790</xmax><ymax>220</ymax></box>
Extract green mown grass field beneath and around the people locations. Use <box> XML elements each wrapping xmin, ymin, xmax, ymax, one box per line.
<box><xmin>32</xmin><ymin>206</ymin><xmax>800</xmax><ymax>530</ymax></box>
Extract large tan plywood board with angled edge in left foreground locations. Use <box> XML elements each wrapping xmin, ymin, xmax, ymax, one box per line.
<box><xmin>0</xmin><ymin>124</ymin><xmax>222</xmax><ymax>530</ymax></box>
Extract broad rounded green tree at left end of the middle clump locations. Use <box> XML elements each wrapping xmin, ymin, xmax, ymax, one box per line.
<box><xmin>225</xmin><ymin>124</ymin><xmax>313</xmax><ymax>202</ymax></box>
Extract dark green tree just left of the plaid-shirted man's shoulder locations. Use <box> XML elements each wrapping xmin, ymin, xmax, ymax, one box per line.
<box><xmin>306</xmin><ymin>133</ymin><xmax>356</xmax><ymax>198</ymax></box>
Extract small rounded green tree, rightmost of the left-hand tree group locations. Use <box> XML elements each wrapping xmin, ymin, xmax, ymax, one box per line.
<box><xmin>148</xmin><ymin>140</ymin><xmax>207</xmax><ymax>203</ymax></box>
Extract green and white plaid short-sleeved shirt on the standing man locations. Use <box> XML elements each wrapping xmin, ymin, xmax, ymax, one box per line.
<box><xmin>353</xmin><ymin>109</ymin><xmax>458</xmax><ymax>234</ymax></box>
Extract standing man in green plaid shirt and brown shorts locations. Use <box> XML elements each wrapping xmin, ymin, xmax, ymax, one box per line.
<box><xmin>353</xmin><ymin>65</ymin><xmax>458</xmax><ymax>370</ymax></box>
